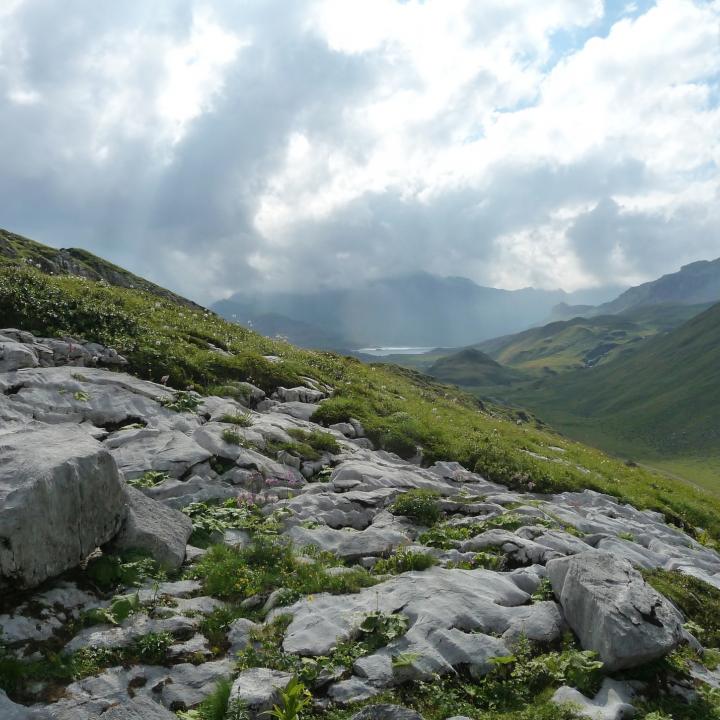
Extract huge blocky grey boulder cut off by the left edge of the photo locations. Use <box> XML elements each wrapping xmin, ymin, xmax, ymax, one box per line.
<box><xmin>0</xmin><ymin>423</ymin><xmax>127</xmax><ymax>589</ymax></box>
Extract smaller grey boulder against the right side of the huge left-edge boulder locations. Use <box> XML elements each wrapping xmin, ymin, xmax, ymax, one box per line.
<box><xmin>112</xmin><ymin>487</ymin><xmax>192</xmax><ymax>570</ymax></box>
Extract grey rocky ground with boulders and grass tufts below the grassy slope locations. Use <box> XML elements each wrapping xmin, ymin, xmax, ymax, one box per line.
<box><xmin>0</xmin><ymin>330</ymin><xmax>720</xmax><ymax>720</ymax></box>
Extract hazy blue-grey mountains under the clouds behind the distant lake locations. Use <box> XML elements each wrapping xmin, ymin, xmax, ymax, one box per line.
<box><xmin>213</xmin><ymin>273</ymin><xmax>617</xmax><ymax>349</ymax></box>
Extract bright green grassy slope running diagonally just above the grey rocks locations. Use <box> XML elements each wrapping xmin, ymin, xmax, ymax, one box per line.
<box><xmin>0</xmin><ymin>239</ymin><xmax>720</xmax><ymax>537</ymax></box>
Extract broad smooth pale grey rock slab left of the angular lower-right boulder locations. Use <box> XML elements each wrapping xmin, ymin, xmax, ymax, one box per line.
<box><xmin>278</xmin><ymin>567</ymin><xmax>564</xmax><ymax>701</ymax></box>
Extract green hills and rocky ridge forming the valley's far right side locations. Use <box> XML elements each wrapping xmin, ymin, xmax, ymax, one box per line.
<box><xmin>392</xmin><ymin>253</ymin><xmax>720</xmax><ymax>488</ymax></box>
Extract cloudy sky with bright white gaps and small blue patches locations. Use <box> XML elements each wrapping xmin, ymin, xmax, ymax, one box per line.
<box><xmin>0</xmin><ymin>0</ymin><xmax>720</xmax><ymax>303</ymax></box>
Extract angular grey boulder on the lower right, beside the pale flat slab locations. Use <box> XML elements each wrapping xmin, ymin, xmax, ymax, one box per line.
<box><xmin>547</xmin><ymin>551</ymin><xmax>683</xmax><ymax>671</ymax></box>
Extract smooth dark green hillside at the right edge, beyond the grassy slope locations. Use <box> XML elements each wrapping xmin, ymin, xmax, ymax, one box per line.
<box><xmin>514</xmin><ymin>304</ymin><xmax>720</xmax><ymax>478</ymax></box>
